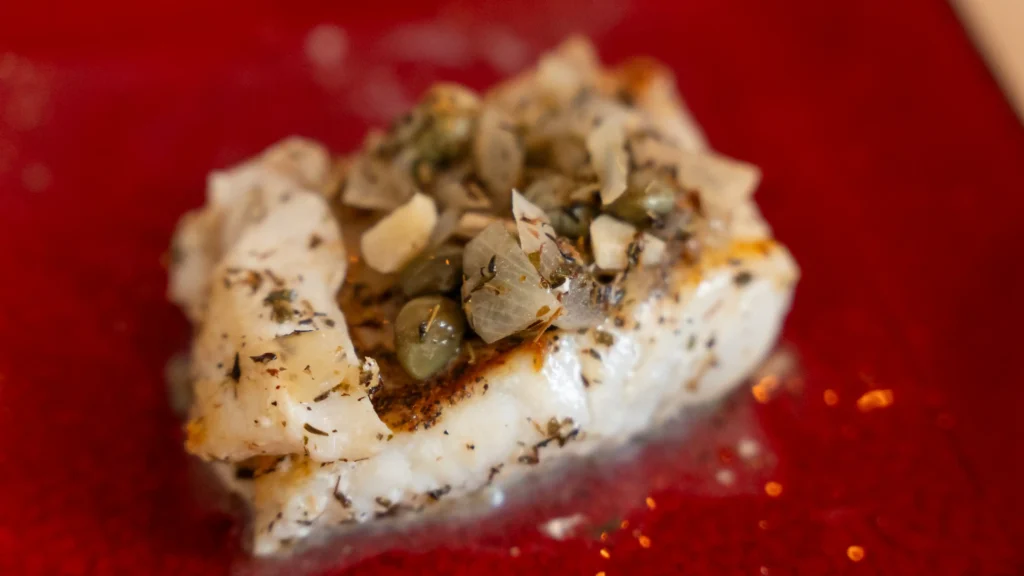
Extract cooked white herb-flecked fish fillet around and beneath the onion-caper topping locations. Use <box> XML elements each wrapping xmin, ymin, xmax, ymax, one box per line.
<box><xmin>171</xmin><ymin>36</ymin><xmax>799</xmax><ymax>554</ymax></box>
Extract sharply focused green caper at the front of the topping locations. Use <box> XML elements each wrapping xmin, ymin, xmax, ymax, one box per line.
<box><xmin>394</xmin><ymin>296</ymin><xmax>466</xmax><ymax>380</ymax></box>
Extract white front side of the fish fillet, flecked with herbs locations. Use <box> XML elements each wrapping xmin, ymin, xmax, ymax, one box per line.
<box><xmin>222</xmin><ymin>240</ymin><xmax>799</xmax><ymax>554</ymax></box>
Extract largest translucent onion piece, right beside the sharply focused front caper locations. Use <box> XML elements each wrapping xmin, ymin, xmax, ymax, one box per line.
<box><xmin>462</xmin><ymin>222</ymin><xmax>559</xmax><ymax>343</ymax></box>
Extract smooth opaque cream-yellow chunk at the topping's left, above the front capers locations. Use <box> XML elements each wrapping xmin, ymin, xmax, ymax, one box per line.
<box><xmin>359</xmin><ymin>194</ymin><xmax>437</xmax><ymax>274</ymax></box>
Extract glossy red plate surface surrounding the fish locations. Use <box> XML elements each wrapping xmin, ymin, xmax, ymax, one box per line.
<box><xmin>0</xmin><ymin>0</ymin><xmax>1024</xmax><ymax>576</ymax></box>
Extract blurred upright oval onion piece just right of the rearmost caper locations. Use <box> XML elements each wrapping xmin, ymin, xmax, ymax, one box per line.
<box><xmin>473</xmin><ymin>107</ymin><xmax>525</xmax><ymax>209</ymax></box>
